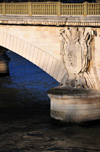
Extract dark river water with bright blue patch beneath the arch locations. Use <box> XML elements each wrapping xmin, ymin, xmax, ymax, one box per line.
<box><xmin>0</xmin><ymin>52</ymin><xmax>100</xmax><ymax>152</ymax></box>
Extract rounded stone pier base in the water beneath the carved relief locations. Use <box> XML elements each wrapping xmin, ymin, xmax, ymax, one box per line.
<box><xmin>47</xmin><ymin>86</ymin><xmax>100</xmax><ymax>123</ymax></box>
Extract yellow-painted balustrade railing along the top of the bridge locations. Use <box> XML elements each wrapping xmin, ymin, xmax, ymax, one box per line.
<box><xmin>0</xmin><ymin>2</ymin><xmax>100</xmax><ymax>16</ymax></box>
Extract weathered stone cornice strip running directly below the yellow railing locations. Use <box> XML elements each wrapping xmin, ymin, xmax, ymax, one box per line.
<box><xmin>0</xmin><ymin>15</ymin><xmax>100</xmax><ymax>27</ymax></box>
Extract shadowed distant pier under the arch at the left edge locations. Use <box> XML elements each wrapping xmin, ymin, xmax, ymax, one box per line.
<box><xmin>0</xmin><ymin>46</ymin><xmax>10</xmax><ymax>77</ymax></box>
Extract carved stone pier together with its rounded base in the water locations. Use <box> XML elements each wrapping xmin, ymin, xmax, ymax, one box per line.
<box><xmin>47</xmin><ymin>27</ymin><xmax>100</xmax><ymax>123</ymax></box>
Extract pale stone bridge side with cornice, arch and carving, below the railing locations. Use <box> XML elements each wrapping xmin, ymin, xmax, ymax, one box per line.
<box><xmin>0</xmin><ymin>15</ymin><xmax>100</xmax><ymax>89</ymax></box>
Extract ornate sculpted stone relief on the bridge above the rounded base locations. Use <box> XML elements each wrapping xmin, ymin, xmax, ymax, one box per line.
<box><xmin>60</xmin><ymin>27</ymin><xmax>93</xmax><ymax>88</ymax></box>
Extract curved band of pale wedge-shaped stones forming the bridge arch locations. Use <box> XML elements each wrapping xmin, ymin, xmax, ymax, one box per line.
<box><xmin>0</xmin><ymin>30</ymin><xmax>66</xmax><ymax>82</ymax></box>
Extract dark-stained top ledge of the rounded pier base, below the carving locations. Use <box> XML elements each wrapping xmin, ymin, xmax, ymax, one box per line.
<box><xmin>47</xmin><ymin>86</ymin><xmax>100</xmax><ymax>98</ymax></box>
